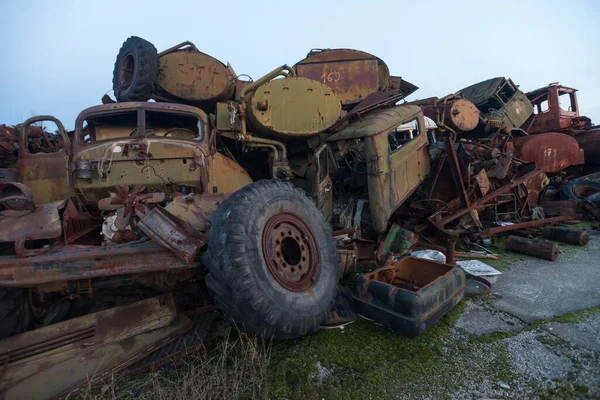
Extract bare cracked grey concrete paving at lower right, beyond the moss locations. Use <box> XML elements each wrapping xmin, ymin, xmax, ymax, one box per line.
<box><xmin>455</xmin><ymin>231</ymin><xmax>600</xmax><ymax>398</ymax></box>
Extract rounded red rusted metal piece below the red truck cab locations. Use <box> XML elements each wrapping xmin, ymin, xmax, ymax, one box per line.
<box><xmin>512</xmin><ymin>132</ymin><xmax>584</xmax><ymax>172</ymax></box>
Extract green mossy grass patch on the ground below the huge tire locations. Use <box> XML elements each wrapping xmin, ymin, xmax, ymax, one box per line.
<box><xmin>270</xmin><ymin>300</ymin><xmax>516</xmax><ymax>399</ymax></box>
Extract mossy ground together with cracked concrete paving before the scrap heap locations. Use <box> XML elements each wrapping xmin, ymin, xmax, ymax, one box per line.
<box><xmin>270</xmin><ymin>230</ymin><xmax>600</xmax><ymax>399</ymax></box>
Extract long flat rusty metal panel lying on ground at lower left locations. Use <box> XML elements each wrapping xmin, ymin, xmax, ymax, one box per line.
<box><xmin>0</xmin><ymin>295</ymin><xmax>191</xmax><ymax>399</ymax></box>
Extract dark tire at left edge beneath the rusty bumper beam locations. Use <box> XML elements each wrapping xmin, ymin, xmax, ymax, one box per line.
<box><xmin>0</xmin><ymin>288</ymin><xmax>32</xmax><ymax>339</ymax></box>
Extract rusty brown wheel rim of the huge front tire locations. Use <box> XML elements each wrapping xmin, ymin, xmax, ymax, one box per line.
<box><xmin>262</xmin><ymin>213</ymin><xmax>321</xmax><ymax>292</ymax></box>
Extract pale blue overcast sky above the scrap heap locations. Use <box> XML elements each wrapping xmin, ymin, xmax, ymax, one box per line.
<box><xmin>0</xmin><ymin>0</ymin><xmax>600</xmax><ymax>129</ymax></box>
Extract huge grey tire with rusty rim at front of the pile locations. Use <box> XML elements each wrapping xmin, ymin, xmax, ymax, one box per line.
<box><xmin>203</xmin><ymin>180</ymin><xmax>341</xmax><ymax>339</ymax></box>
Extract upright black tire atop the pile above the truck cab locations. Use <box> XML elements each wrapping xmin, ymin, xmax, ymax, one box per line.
<box><xmin>113</xmin><ymin>36</ymin><xmax>159</xmax><ymax>101</ymax></box>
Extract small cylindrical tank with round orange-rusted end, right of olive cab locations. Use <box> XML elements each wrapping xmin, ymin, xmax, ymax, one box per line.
<box><xmin>423</xmin><ymin>99</ymin><xmax>479</xmax><ymax>132</ymax></box>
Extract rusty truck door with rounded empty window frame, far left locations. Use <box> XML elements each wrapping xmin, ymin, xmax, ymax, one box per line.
<box><xmin>17</xmin><ymin>115</ymin><xmax>74</xmax><ymax>204</ymax></box>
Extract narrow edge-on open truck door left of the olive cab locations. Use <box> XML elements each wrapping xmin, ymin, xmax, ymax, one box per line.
<box><xmin>313</xmin><ymin>143</ymin><xmax>336</xmax><ymax>222</ymax></box>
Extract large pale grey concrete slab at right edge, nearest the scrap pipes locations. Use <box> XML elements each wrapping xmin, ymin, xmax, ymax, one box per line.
<box><xmin>491</xmin><ymin>234</ymin><xmax>600</xmax><ymax>323</ymax></box>
